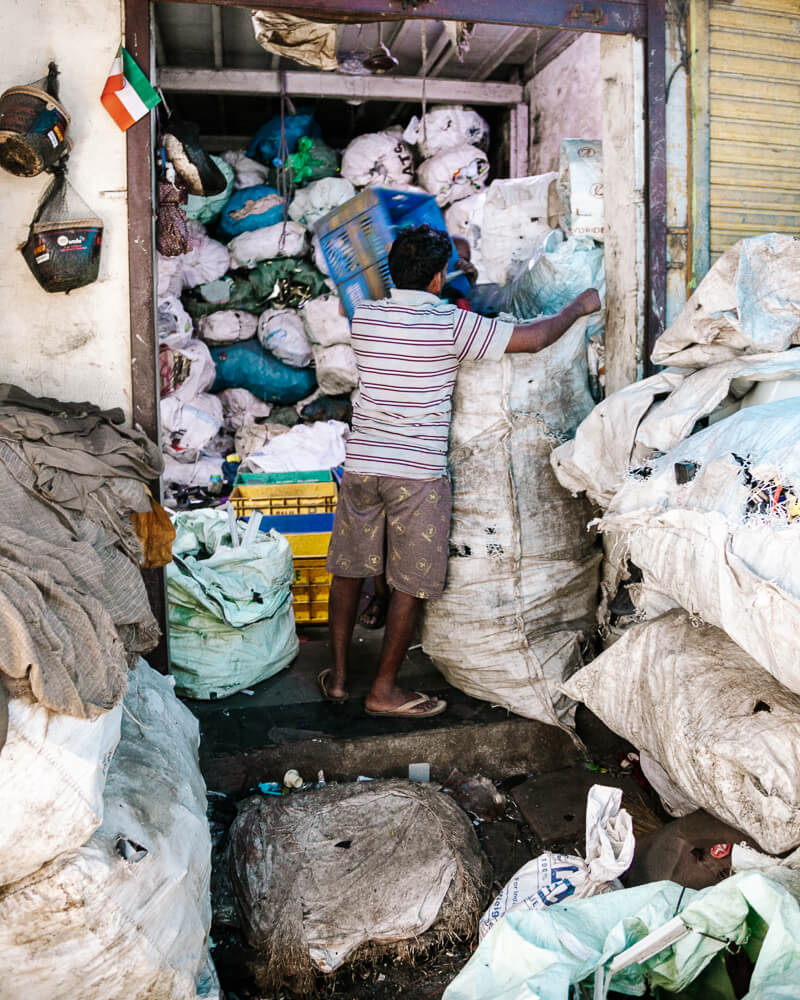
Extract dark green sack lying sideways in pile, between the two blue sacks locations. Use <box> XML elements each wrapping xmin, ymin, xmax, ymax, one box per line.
<box><xmin>183</xmin><ymin>257</ymin><xmax>330</xmax><ymax>319</ymax></box>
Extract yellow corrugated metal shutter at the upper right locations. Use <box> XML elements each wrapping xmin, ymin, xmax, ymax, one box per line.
<box><xmin>708</xmin><ymin>0</ymin><xmax>800</xmax><ymax>263</ymax></box>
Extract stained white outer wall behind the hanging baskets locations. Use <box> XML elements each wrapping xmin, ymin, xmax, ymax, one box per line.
<box><xmin>0</xmin><ymin>0</ymin><xmax>131</xmax><ymax>416</ymax></box>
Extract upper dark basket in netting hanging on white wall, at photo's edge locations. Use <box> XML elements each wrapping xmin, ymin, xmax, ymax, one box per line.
<box><xmin>0</xmin><ymin>63</ymin><xmax>72</xmax><ymax>177</ymax></box>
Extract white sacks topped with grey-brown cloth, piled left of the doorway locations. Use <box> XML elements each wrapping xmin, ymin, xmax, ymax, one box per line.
<box><xmin>0</xmin><ymin>385</ymin><xmax>213</xmax><ymax>1000</ymax></box>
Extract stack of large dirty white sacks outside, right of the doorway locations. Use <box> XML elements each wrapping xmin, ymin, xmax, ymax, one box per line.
<box><xmin>552</xmin><ymin>234</ymin><xmax>800</xmax><ymax>851</ymax></box>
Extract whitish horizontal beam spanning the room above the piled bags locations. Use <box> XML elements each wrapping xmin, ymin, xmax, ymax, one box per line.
<box><xmin>158</xmin><ymin>66</ymin><xmax>523</xmax><ymax>105</ymax></box>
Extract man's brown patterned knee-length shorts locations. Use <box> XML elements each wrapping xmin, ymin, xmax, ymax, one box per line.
<box><xmin>328</xmin><ymin>472</ymin><xmax>452</xmax><ymax>598</ymax></box>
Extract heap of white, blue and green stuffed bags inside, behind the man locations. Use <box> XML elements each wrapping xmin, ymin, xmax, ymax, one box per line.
<box><xmin>158</xmin><ymin>107</ymin><xmax>504</xmax><ymax>507</ymax></box>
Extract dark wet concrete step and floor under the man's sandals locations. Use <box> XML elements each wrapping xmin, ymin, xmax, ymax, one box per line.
<box><xmin>187</xmin><ymin>627</ymin><xmax>578</xmax><ymax>796</ymax></box>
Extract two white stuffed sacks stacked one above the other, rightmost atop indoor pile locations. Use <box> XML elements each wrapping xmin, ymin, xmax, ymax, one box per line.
<box><xmin>410</xmin><ymin>107</ymin><xmax>489</xmax><ymax>208</ymax></box>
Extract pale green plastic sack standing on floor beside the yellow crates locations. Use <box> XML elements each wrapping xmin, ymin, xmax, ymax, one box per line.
<box><xmin>167</xmin><ymin>509</ymin><xmax>298</xmax><ymax>699</ymax></box>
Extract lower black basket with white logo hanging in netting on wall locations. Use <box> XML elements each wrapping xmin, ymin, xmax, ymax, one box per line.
<box><xmin>21</xmin><ymin>165</ymin><xmax>103</xmax><ymax>292</ymax></box>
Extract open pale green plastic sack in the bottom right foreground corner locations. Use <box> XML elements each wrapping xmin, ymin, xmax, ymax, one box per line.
<box><xmin>443</xmin><ymin>871</ymin><xmax>800</xmax><ymax>1000</ymax></box>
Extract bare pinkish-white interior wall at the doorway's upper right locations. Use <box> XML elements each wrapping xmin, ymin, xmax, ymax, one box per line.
<box><xmin>528</xmin><ymin>32</ymin><xmax>603</xmax><ymax>174</ymax></box>
